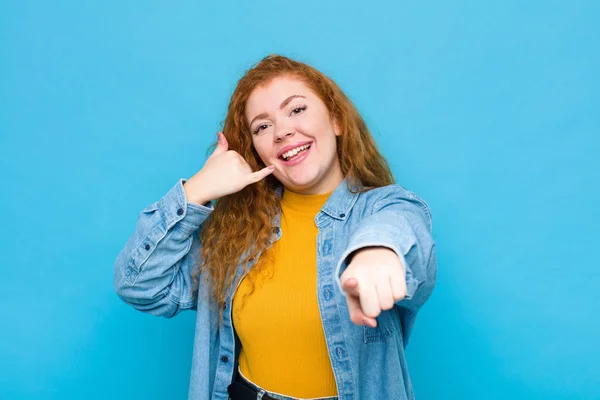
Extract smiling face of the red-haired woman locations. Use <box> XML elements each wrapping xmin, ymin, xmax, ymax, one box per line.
<box><xmin>246</xmin><ymin>77</ymin><xmax>344</xmax><ymax>194</ymax></box>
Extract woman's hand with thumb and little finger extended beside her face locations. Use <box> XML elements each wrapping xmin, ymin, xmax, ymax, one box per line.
<box><xmin>183</xmin><ymin>132</ymin><xmax>275</xmax><ymax>204</ymax></box>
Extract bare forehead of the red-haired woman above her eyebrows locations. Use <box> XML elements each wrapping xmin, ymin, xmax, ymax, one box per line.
<box><xmin>246</xmin><ymin>77</ymin><xmax>314</xmax><ymax>118</ymax></box>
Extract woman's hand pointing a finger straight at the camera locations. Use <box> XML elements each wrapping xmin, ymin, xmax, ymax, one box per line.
<box><xmin>340</xmin><ymin>247</ymin><xmax>406</xmax><ymax>327</ymax></box>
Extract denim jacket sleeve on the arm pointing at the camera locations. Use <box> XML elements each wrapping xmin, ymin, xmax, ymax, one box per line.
<box><xmin>335</xmin><ymin>185</ymin><xmax>437</xmax><ymax>311</ymax></box>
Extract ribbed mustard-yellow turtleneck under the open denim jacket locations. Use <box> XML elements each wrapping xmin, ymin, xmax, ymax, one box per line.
<box><xmin>232</xmin><ymin>189</ymin><xmax>337</xmax><ymax>398</ymax></box>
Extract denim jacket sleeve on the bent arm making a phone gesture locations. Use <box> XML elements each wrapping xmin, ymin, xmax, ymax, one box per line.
<box><xmin>114</xmin><ymin>179</ymin><xmax>212</xmax><ymax>318</ymax></box>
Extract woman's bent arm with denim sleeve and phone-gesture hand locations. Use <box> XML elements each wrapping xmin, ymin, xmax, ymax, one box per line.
<box><xmin>115</xmin><ymin>132</ymin><xmax>274</xmax><ymax>317</ymax></box>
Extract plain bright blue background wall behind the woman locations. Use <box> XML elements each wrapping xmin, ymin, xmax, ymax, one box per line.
<box><xmin>0</xmin><ymin>0</ymin><xmax>600</xmax><ymax>400</ymax></box>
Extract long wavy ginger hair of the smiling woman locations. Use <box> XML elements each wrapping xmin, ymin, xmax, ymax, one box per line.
<box><xmin>193</xmin><ymin>54</ymin><xmax>394</xmax><ymax>321</ymax></box>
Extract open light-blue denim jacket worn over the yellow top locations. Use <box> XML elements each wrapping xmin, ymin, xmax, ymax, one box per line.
<box><xmin>114</xmin><ymin>179</ymin><xmax>437</xmax><ymax>400</ymax></box>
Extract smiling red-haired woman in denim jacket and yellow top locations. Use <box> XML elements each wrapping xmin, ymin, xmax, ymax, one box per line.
<box><xmin>115</xmin><ymin>55</ymin><xmax>437</xmax><ymax>400</ymax></box>
